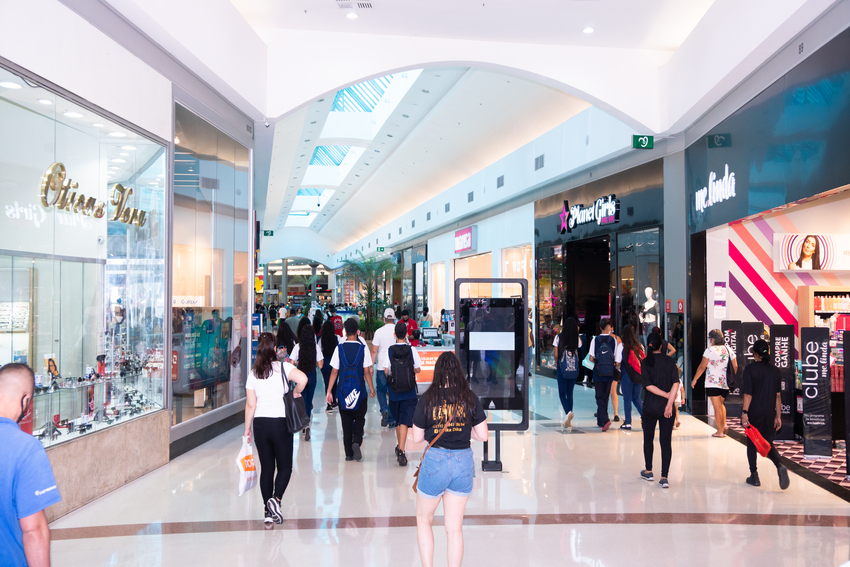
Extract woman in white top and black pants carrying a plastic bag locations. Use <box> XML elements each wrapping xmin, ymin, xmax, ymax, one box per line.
<box><xmin>245</xmin><ymin>332</ymin><xmax>307</xmax><ymax>529</ymax></box>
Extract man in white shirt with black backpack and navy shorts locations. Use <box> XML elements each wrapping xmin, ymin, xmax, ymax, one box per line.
<box><xmin>386</xmin><ymin>321</ymin><xmax>422</xmax><ymax>467</ymax></box>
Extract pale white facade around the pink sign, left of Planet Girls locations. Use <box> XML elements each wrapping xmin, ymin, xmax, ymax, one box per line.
<box><xmin>428</xmin><ymin>203</ymin><xmax>535</xmax><ymax>315</ymax></box>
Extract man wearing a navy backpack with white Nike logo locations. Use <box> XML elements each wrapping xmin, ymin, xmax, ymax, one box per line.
<box><xmin>327</xmin><ymin>319</ymin><xmax>375</xmax><ymax>461</ymax></box>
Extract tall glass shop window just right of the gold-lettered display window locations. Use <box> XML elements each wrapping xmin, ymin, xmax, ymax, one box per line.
<box><xmin>172</xmin><ymin>105</ymin><xmax>251</xmax><ymax>424</ymax></box>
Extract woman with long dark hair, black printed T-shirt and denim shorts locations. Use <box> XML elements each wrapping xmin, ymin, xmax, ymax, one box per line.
<box><xmin>413</xmin><ymin>352</ymin><xmax>487</xmax><ymax>567</ymax></box>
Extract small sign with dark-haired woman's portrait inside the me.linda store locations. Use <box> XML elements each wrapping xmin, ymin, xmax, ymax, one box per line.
<box><xmin>773</xmin><ymin>234</ymin><xmax>850</xmax><ymax>272</ymax></box>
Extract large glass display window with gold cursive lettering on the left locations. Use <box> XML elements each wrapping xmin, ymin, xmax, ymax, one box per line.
<box><xmin>0</xmin><ymin>69</ymin><xmax>166</xmax><ymax>445</ymax></box>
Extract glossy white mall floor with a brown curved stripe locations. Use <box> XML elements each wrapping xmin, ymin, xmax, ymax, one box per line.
<box><xmin>51</xmin><ymin>377</ymin><xmax>850</xmax><ymax>567</ymax></box>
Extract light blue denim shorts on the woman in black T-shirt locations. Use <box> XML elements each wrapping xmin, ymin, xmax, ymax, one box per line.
<box><xmin>417</xmin><ymin>447</ymin><xmax>475</xmax><ymax>498</ymax></box>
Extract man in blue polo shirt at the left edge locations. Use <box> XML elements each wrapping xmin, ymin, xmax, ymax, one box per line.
<box><xmin>0</xmin><ymin>364</ymin><xmax>62</xmax><ymax>567</ymax></box>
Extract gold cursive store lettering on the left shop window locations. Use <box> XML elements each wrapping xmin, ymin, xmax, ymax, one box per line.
<box><xmin>41</xmin><ymin>162</ymin><xmax>147</xmax><ymax>227</ymax></box>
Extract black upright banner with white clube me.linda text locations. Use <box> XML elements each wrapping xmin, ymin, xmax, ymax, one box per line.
<box><xmin>800</xmin><ymin>327</ymin><xmax>832</xmax><ymax>458</ymax></box>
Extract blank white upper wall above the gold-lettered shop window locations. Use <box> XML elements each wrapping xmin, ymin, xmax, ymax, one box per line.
<box><xmin>0</xmin><ymin>0</ymin><xmax>172</xmax><ymax>140</ymax></box>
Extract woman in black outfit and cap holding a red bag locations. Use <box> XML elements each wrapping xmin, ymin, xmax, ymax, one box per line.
<box><xmin>741</xmin><ymin>340</ymin><xmax>791</xmax><ymax>490</ymax></box>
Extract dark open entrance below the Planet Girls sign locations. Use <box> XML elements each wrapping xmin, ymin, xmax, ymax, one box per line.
<box><xmin>564</xmin><ymin>236</ymin><xmax>613</xmax><ymax>336</ymax></box>
